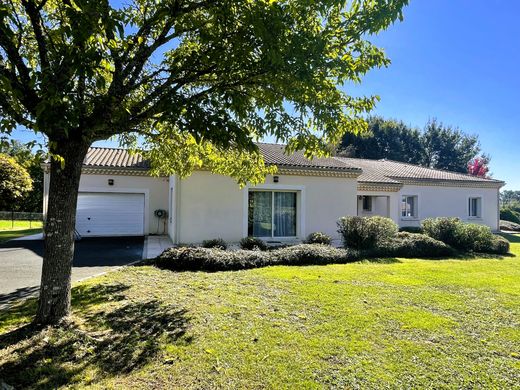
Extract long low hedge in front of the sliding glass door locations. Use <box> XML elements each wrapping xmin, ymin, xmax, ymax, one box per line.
<box><xmin>153</xmin><ymin>244</ymin><xmax>362</xmax><ymax>271</ymax></box>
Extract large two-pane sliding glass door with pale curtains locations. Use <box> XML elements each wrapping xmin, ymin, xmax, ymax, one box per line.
<box><xmin>247</xmin><ymin>191</ymin><xmax>296</xmax><ymax>237</ymax></box>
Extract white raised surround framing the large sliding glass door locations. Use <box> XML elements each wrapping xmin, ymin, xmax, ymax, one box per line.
<box><xmin>242</xmin><ymin>184</ymin><xmax>305</xmax><ymax>241</ymax></box>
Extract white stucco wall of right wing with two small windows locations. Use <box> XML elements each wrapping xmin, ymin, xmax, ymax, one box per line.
<box><xmin>394</xmin><ymin>185</ymin><xmax>498</xmax><ymax>230</ymax></box>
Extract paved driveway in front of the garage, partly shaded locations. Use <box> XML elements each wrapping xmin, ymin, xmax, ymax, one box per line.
<box><xmin>0</xmin><ymin>237</ymin><xmax>144</xmax><ymax>309</ymax></box>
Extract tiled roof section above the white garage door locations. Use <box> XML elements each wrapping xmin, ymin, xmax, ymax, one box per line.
<box><xmin>83</xmin><ymin>147</ymin><xmax>150</xmax><ymax>169</ymax></box>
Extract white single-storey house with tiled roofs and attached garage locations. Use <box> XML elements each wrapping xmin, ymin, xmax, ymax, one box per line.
<box><xmin>44</xmin><ymin>143</ymin><xmax>504</xmax><ymax>243</ymax></box>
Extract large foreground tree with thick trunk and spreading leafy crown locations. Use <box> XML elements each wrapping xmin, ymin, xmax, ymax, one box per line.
<box><xmin>0</xmin><ymin>0</ymin><xmax>408</xmax><ymax>324</ymax></box>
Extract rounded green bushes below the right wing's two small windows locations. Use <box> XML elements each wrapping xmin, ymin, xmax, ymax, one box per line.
<box><xmin>423</xmin><ymin>218</ymin><xmax>509</xmax><ymax>254</ymax></box>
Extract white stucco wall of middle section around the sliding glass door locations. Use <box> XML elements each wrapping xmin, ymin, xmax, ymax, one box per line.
<box><xmin>174</xmin><ymin>172</ymin><xmax>357</xmax><ymax>243</ymax></box>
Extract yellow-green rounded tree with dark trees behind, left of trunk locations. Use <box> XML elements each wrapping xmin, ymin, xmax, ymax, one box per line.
<box><xmin>0</xmin><ymin>138</ymin><xmax>44</xmax><ymax>213</ymax></box>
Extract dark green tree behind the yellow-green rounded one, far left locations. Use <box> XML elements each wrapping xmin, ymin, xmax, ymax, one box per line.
<box><xmin>0</xmin><ymin>139</ymin><xmax>43</xmax><ymax>213</ymax></box>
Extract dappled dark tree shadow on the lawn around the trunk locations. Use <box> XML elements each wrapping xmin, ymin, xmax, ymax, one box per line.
<box><xmin>0</xmin><ymin>284</ymin><xmax>191</xmax><ymax>388</ymax></box>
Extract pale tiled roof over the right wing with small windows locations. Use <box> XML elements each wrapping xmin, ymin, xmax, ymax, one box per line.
<box><xmin>335</xmin><ymin>157</ymin><xmax>503</xmax><ymax>184</ymax></box>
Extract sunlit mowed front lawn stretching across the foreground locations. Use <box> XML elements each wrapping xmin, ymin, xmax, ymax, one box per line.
<box><xmin>0</xmin><ymin>235</ymin><xmax>520</xmax><ymax>389</ymax></box>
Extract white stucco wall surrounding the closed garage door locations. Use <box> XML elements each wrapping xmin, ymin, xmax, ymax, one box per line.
<box><xmin>43</xmin><ymin>173</ymin><xmax>168</xmax><ymax>234</ymax></box>
